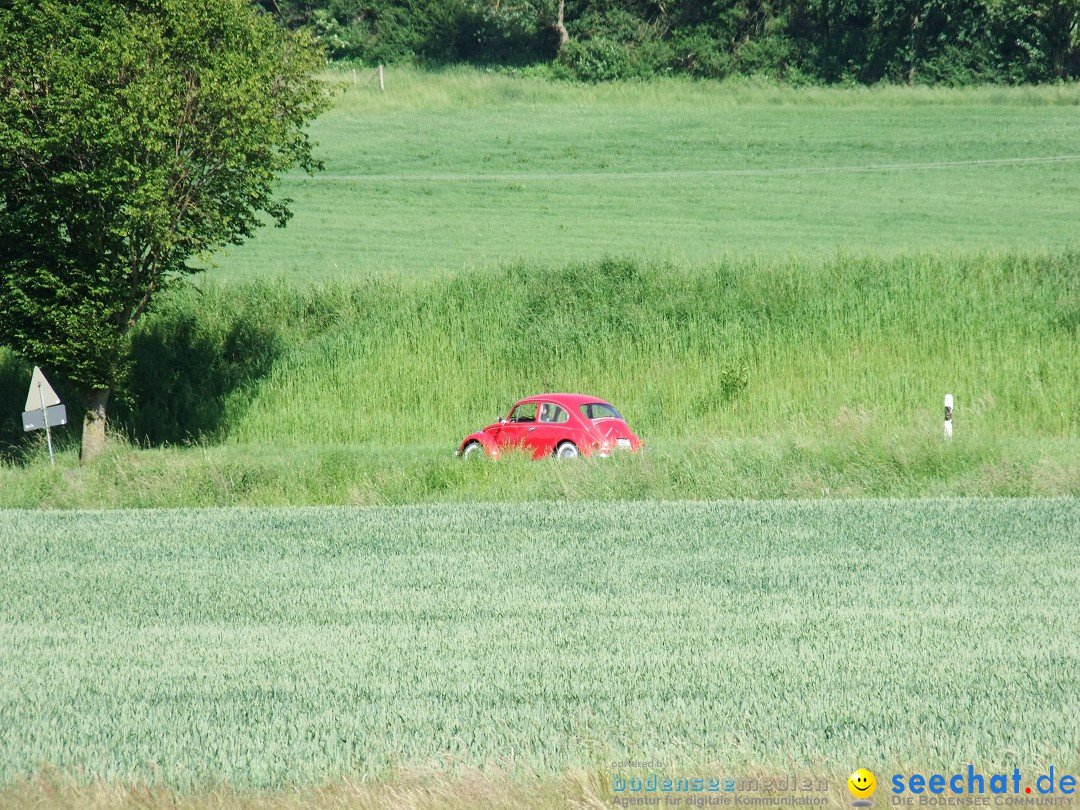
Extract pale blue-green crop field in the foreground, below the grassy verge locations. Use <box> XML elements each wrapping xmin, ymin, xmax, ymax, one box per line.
<box><xmin>0</xmin><ymin>500</ymin><xmax>1080</xmax><ymax>786</ymax></box>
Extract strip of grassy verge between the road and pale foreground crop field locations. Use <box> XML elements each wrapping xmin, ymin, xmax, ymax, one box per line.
<box><xmin>0</xmin><ymin>434</ymin><xmax>1080</xmax><ymax>509</ymax></box>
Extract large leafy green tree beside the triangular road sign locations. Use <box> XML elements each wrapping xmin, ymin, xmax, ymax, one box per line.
<box><xmin>0</xmin><ymin>0</ymin><xmax>327</xmax><ymax>461</ymax></box>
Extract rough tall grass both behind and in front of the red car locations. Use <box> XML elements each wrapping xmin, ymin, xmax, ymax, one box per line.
<box><xmin>0</xmin><ymin>254</ymin><xmax>1080</xmax><ymax>505</ymax></box>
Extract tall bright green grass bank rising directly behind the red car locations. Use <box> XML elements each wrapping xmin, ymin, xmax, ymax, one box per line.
<box><xmin>204</xmin><ymin>255</ymin><xmax>1080</xmax><ymax>447</ymax></box>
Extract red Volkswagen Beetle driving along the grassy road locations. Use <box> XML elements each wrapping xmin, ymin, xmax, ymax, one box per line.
<box><xmin>456</xmin><ymin>394</ymin><xmax>642</xmax><ymax>458</ymax></box>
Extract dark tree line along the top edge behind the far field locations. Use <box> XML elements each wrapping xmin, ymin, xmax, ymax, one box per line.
<box><xmin>258</xmin><ymin>0</ymin><xmax>1080</xmax><ymax>84</ymax></box>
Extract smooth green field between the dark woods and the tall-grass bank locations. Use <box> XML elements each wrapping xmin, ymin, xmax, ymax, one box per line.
<box><xmin>208</xmin><ymin>71</ymin><xmax>1080</xmax><ymax>279</ymax></box>
